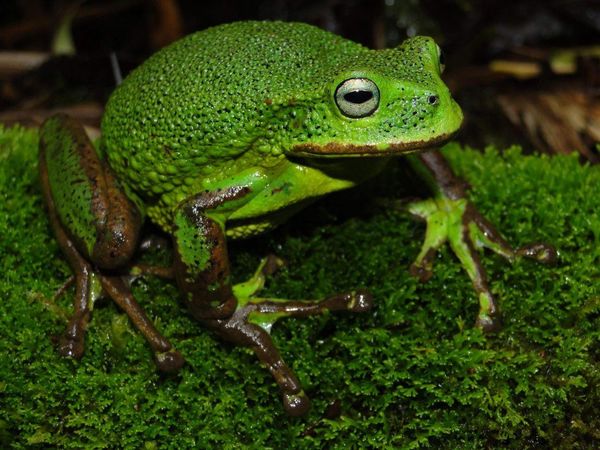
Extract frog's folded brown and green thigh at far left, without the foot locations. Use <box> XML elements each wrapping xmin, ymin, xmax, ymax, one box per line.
<box><xmin>40</xmin><ymin>115</ymin><xmax>141</xmax><ymax>269</ymax></box>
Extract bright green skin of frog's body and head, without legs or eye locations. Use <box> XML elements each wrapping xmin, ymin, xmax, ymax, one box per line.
<box><xmin>102</xmin><ymin>22</ymin><xmax>462</xmax><ymax>235</ymax></box>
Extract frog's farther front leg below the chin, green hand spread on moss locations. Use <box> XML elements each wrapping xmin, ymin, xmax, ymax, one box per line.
<box><xmin>409</xmin><ymin>151</ymin><xmax>556</xmax><ymax>331</ymax></box>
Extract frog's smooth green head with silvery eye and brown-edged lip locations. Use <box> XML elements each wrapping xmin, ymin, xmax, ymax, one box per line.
<box><xmin>290</xmin><ymin>36</ymin><xmax>463</xmax><ymax>156</ymax></box>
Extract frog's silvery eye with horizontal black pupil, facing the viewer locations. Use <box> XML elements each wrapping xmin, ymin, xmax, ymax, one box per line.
<box><xmin>335</xmin><ymin>78</ymin><xmax>379</xmax><ymax>119</ymax></box>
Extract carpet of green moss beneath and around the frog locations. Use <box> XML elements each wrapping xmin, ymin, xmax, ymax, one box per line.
<box><xmin>0</xmin><ymin>124</ymin><xmax>600</xmax><ymax>449</ymax></box>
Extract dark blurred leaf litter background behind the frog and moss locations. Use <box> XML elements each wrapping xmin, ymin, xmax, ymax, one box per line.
<box><xmin>0</xmin><ymin>0</ymin><xmax>600</xmax><ymax>163</ymax></box>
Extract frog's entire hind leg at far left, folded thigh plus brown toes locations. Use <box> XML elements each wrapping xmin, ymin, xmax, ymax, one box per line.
<box><xmin>39</xmin><ymin>116</ymin><xmax>184</xmax><ymax>371</ymax></box>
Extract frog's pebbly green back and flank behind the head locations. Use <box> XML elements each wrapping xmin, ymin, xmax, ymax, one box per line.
<box><xmin>102</xmin><ymin>22</ymin><xmax>363</xmax><ymax>194</ymax></box>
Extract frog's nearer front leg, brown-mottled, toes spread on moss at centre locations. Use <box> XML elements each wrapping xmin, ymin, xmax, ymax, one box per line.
<box><xmin>173</xmin><ymin>193</ymin><xmax>372</xmax><ymax>416</ymax></box>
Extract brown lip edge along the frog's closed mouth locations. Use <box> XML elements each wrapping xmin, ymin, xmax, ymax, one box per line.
<box><xmin>291</xmin><ymin>133</ymin><xmax>456</xmax><ymax>157</ymax></box>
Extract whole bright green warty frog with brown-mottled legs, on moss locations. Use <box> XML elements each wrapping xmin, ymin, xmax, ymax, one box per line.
<box><xmin>40</xmin><ymin>22</ymin><xmax>554</xmax><ymax>415</ymax></box>
